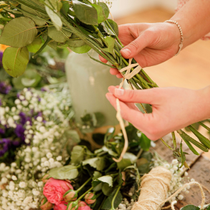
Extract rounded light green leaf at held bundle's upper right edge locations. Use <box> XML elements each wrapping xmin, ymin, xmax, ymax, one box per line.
<box><xmin>92</xmin><ymin>2</ymin><xmax>109</xmax><ymax>23</ymax></box>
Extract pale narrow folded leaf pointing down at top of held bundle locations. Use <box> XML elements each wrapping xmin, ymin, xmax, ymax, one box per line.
<box><xmin>45</xmin><ymin>0</ymin><xmax>63</xmax><ymax>31</ymax></box>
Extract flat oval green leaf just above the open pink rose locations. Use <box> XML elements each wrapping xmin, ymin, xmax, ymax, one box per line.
<box><xmin>49</xmin><ymin>165</ymin><xmax>79</xmax><ymax>180</ymax></box>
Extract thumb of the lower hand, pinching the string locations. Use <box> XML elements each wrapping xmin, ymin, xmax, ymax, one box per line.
<box><xmin>110</xmin><ymin>88</ymin><xmax>159</xmax><ymax>104</ymax></box>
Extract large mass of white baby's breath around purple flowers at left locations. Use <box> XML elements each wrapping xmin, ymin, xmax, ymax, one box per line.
<box><xmin>0</xmin><ymin>86</ymin><xmax>73</xmax><ymax>210</ymax></box>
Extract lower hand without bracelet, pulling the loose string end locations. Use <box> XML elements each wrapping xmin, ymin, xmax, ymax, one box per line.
<box><xmin>106</xmin><ymin>86</ymin><xmax>210</xmax><ymax>140</ymax></box>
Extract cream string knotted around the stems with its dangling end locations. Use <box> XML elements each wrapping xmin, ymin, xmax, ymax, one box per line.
<box><xmin>113</xmin><ymin>58</ymin><xmax>142</xmax><ymax>162</ymax></box>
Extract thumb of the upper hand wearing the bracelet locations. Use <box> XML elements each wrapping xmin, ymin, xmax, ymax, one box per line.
<box><xmin>120</xmin><ymin>33</ymin><xmax>148</xmax><ymax>58</ymax></box>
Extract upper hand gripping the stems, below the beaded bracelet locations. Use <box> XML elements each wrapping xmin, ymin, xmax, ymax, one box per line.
<box><xmin>100</xmin><ymin>23</ymin><xmax>180</xmax><ymax>78</ymax></box>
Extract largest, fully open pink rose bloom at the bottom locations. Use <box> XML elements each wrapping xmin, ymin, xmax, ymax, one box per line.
<box><xmin>43</xmin><ymin>178</ymin><xmax>73</xmax><ymax>205</ymax></box>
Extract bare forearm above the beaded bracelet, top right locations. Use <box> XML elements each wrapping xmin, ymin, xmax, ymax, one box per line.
<box><xmin>171</xmin><ymin>0</ymin><xmax>210</xmax><ymax>47</ymax></box>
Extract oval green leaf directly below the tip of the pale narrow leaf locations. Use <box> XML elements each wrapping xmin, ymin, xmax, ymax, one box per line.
<box><xmin>48</xmin><ymin>27</ymin><xmax>72</xmax><ymax>43</ymax></box>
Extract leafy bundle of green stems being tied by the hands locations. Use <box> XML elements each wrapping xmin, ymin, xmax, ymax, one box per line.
<box><xmin>0</xmin><ymin>0</ymin><xmax>210</xmax><ymax>164</ymax></box>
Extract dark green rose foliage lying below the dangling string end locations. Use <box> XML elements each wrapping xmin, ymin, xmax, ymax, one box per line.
<box><xmin>45</xmin><ymin>125</ymin><xmax>152</xmax><ymax>210</ymax></box>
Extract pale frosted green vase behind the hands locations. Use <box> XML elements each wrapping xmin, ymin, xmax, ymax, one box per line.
<box><xmin>65</xmin><ymin>51</ymin><xmax>121</xmax><ymax>126</ymax></box>
